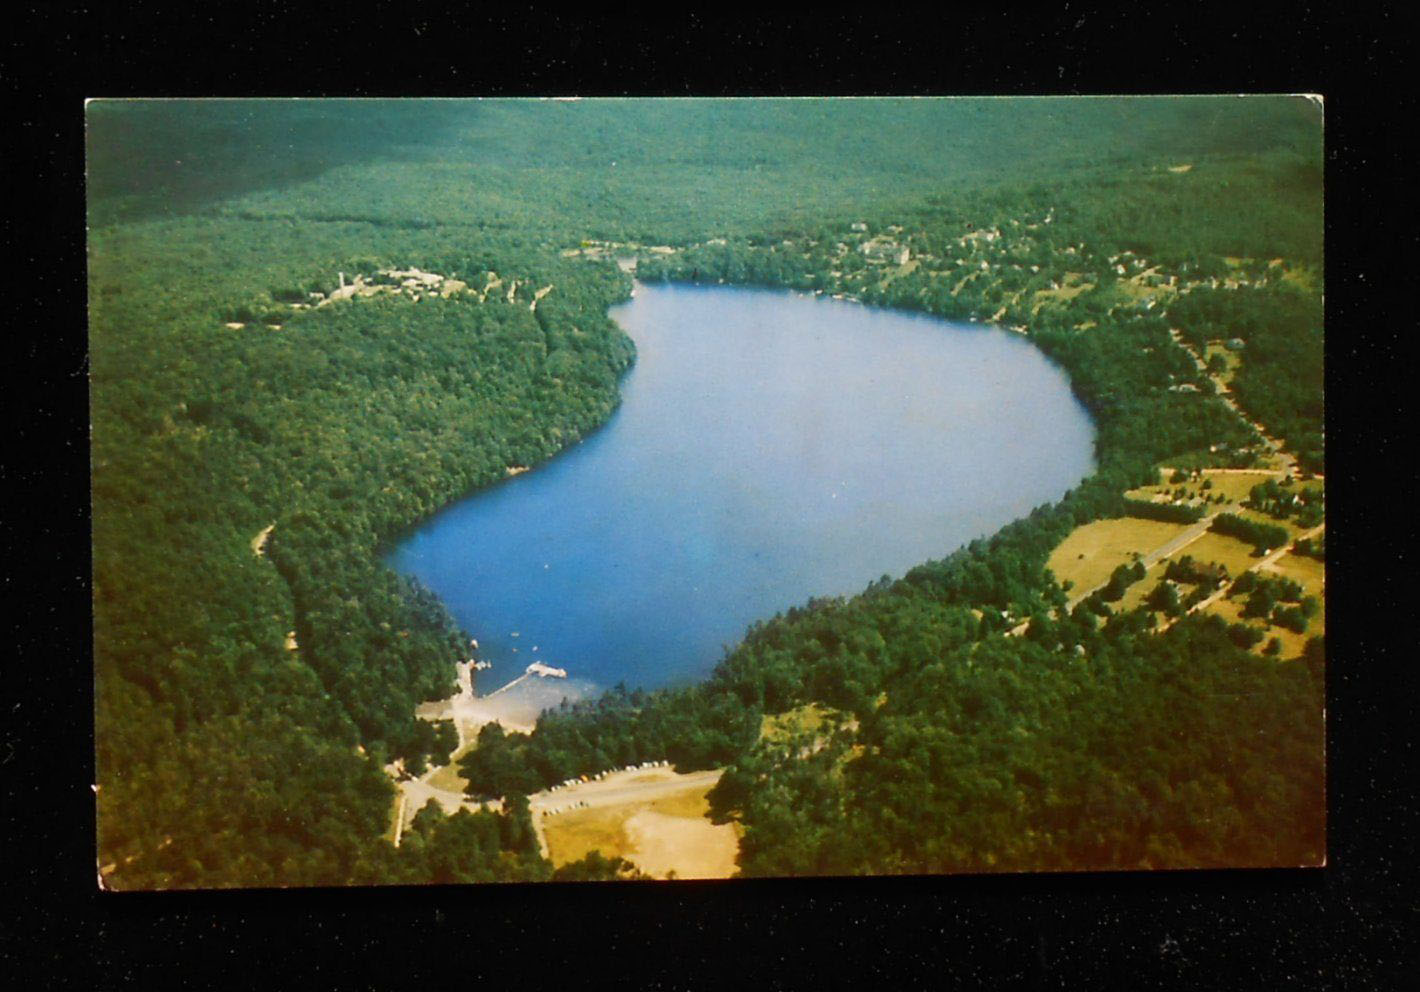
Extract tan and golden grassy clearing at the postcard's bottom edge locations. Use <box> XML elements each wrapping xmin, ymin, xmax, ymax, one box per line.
<box><xmin>541</xmin><ymin>771</ymin><xmax>740</xmax><ymax>878</ymax></box>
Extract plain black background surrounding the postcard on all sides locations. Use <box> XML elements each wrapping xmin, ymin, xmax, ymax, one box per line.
<box><xmin>0</xmin><ymin>3</ymin><xmax>1420</xmax><ymax>989</ymax></box>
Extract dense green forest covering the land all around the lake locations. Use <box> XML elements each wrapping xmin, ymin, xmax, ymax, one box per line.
<box><xmin>89</xmin><ymin>99</ymin><xmax>1325</xmax><ymax>888</ymax></box>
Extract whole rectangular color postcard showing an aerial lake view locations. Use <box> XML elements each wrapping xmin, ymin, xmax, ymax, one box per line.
<box><xmin>85</xmin><ymin>95</ymin><xmax>1326</xmax><ymax>891</ymax></box>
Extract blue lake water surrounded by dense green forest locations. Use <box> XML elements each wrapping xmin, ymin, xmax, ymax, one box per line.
<box><xmin>388</xmin><ymin>285</ymin><xmax>1093</xmax><ymax>702</ymax></box>
